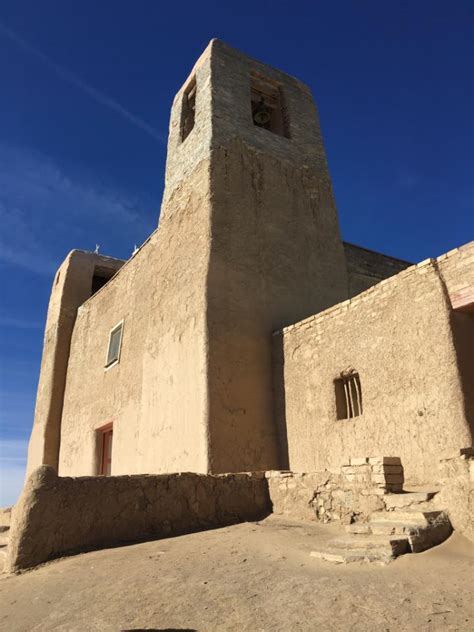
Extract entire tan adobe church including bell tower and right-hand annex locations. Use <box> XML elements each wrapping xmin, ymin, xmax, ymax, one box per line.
<box><xmin>28</xmin><ymin>40</ymin><xmax>474</xmax><ymax>492</ymax></box>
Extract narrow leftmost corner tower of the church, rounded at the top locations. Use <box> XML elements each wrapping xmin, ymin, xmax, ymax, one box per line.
<box><xmin>27</xmin><ymin>250</ymin><xmax>124</xmax><ymax>474</ymax></box>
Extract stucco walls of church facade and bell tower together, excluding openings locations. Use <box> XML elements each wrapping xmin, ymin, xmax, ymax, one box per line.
<box><xmin>46</xmin><ymin>41</ymin><xmax>347</xmax><ymax>475</ymax></box>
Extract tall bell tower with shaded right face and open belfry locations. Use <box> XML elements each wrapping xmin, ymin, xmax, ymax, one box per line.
<box><xmin>160</xmin><ymin>40</ymin><xmax>348</xmax><ymax>472</ymax></box>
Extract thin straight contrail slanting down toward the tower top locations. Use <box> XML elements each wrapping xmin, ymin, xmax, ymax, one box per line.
<box><xmin>0</xmin><ymin>21</ymin><xmax>166</xmax><ymax>143</ymax></box>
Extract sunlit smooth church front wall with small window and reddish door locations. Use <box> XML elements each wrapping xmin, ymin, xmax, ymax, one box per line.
<box><xmin>59</xmin><ymin>161</ymin><xmax>213</xmax><ymax>476</ymax></box>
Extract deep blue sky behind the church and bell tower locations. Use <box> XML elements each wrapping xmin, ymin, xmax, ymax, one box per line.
<box><xmin>0</xmin><ymin>0</ymin><xmax>474</xmax><ymax>506</ymax></box>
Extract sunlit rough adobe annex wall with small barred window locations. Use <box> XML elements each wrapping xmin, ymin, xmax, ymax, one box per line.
<box><xmin>274</xmin><ymin>244</ymin><xmax>473</xmax><ymax>484</ymax></box>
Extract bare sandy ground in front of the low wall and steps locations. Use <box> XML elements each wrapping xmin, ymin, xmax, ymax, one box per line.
<box><xmin>0</xmin><ymin>517</ymin><xmax>474</xmax><ymax>632</ymax></box>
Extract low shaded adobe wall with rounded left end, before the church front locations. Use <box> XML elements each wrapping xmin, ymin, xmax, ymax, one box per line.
<box><xmin>5</xmin><ymin>466</ymin><xmax>271</xmax><ymax>572</ymax></box>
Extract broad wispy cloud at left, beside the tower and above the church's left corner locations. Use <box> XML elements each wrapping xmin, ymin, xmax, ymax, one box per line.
<box><xmin>0</xmin><ymin>142</ymin><xmax>148</xmax><ymax>276</ymax></box>
